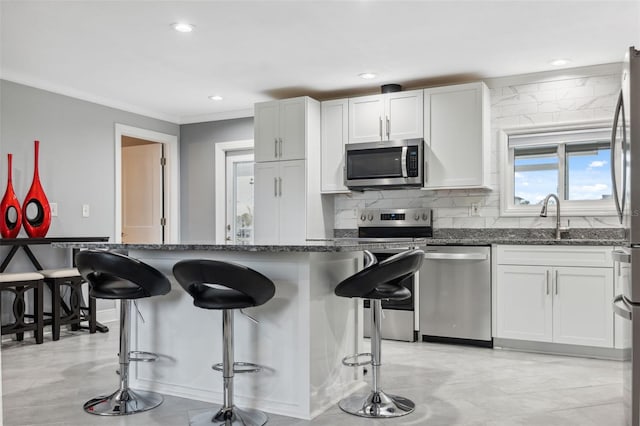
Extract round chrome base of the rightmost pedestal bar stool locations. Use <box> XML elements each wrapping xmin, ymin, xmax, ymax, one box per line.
<box><xmin>338</xmin><ymin>391</ymin><xmax>416</xmax><ymax>418</ymax></box>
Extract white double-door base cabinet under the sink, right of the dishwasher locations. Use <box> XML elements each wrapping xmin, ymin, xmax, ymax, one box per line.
<box><xmin>495</xmin><ymin>246</ymin><xmax>614</xmax><ymax>348</ymax></box>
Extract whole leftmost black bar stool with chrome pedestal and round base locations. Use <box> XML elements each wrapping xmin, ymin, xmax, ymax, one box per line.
<box><xmin>76</xmin><ymin>250</ymin><xmax>171</xmax><ymax>416</ymax></box>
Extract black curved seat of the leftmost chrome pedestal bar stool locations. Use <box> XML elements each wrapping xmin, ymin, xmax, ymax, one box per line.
<box><xmin>76</xmin><ymin>250</ymin><xmax>171</xmax><ymax>299</ymax></box>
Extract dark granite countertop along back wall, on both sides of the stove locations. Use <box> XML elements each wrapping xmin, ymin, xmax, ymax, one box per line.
<box><xmin>336</xmin><ymin>228</ymin><xmax>627</xmax><ymax>246</ymax></box>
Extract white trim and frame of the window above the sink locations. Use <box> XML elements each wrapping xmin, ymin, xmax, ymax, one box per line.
<box><xmin>498</xmin><ymin>120</ymin><xmax>616</xmax><ymax>217</ymax></box>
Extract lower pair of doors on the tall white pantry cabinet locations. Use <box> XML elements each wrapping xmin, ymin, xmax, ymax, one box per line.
<box><xmin>254</xmin><ymin>160</ymin><xmax>306</xmax><ymax>244</ymax></box>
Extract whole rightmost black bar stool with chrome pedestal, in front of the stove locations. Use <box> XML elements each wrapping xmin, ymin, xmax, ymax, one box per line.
<box><xmin>335</xmin><ymin>250</ymin><xmax>424</xmax><ymax>418</ymax></box>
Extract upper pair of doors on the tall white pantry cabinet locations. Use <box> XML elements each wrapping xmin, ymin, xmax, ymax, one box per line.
<box><xmin>254</xmin><ymin>97</ymin><xmax>312</xmax><ymax>163</ymax></box>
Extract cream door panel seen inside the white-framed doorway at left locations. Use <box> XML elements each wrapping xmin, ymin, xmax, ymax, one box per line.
<box><xmin>122</xmin><ymin>143</ymin><xmax>164</xmax><ymax>244</ymax></box>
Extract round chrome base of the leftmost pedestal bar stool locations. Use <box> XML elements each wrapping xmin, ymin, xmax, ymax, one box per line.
<box><xmin>83</xmin><ymin>389</ymin><xmax>163</xmax><ymax>416</ymax></box>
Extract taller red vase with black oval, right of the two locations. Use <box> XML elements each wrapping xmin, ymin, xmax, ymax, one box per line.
<box><xmin>22</xmin><ymin>141</ymin><xmax>51</xmax><ymax>238</ymax></box>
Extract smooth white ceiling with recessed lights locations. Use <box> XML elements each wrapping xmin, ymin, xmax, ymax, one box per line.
<box><xmin>0</xmin><ymin>0</ymin><xmax>640</xmax><ymax>123</ymax></box>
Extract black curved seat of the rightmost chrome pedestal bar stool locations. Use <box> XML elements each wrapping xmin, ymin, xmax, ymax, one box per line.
<box><xmin>335</xmin><ymin>250</ymin><xmax>424</xmax><ymax>300</ymax></box>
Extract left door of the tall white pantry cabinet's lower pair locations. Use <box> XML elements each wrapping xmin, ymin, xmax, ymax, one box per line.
<box><xmin>253</xmin><ymin>161</ymin><xmax>280</xmax><ymax>244</ymax></box>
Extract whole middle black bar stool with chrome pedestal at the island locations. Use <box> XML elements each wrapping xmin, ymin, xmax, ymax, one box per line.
<box><xmin>173</xmin><ymin>259</ymin><xmax>275</xmax><ymax>426</ymax></box>
